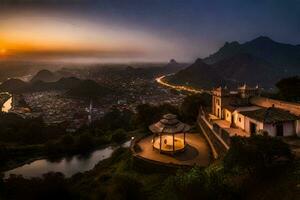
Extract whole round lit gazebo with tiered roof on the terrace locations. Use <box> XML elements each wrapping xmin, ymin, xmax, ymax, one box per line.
<box><xmin>149</xmin><ymin>114</ymin><xmax>190</xmax><ymax>154</ymax></box>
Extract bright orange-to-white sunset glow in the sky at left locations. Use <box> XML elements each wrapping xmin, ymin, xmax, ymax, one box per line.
<box><xmin>0</xmin><ymin>14</ymin><xmax>179</xmax><ymax>61</ymax></box>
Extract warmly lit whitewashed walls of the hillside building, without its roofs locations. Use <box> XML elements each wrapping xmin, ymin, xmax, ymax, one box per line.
<box><xmin>212</xmin><ymin>88</ymin><xmax>300</xmax><ymax>137</ymax></box>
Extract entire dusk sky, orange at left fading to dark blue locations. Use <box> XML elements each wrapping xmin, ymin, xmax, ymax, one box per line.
<box><xmin>0</xmin><ymin>0</ymin><xmax>300</xmax><ymax>62</ymax></box>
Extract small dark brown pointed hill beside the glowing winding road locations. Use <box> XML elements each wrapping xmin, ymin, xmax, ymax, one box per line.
<box><xmin>168</xmin><ymin>58</ymin><xmax>223</xmax><ymax>88</ymax></box>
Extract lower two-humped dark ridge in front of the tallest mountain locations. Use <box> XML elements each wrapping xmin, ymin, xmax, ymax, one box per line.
<box><xmin>169</xmin><ymin>53</ymin><xmax>282</xmax><ymax>89</ymax></box>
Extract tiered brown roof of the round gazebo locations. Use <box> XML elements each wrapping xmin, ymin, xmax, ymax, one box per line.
<box><xmin>149</xmin><ymin>114</ymin><xmax>190</xmax><ymax>133</ymax></box>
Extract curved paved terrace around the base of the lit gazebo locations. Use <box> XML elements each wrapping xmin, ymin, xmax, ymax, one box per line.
<box><xmin>138</xmin><ymin>133</ymin><xmax>211</xmax><ymax>166</ymax></box>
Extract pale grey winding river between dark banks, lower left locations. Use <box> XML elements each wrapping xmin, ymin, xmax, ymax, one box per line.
<box><xmin>4</xmin><ymin>141</ymin><xmax>131</xmax><ymax>179</ymax></box>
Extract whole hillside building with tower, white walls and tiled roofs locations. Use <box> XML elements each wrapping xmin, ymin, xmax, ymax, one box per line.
<box><xmin>212</xmin><ymin>85</ymin><xmax>300</xmax><ymax>137</ymax></box>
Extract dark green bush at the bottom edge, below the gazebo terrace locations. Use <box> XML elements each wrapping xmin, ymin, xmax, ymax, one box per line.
<box><xmin>161</xmin><ymin>167</ymin><xmax>236</xmax><ymax>200</ymax></box>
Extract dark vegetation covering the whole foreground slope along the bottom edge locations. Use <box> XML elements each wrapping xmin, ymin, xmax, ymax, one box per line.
<box><xmin>0</xmin><ymin>136</ymin><xmax>300</xmax><ymax>200</ymax></box>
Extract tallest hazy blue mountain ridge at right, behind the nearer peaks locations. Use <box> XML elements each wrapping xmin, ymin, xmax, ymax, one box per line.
<box><xmin>204</xmin><ymin>36</ymin><xmax>300</xmax><ymax>74</ymax></box>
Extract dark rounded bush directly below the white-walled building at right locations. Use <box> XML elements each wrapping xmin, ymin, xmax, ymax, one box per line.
<box><xmin>224</xmin><ymin>135</ymin><xmax>292</xmax><ymax>174</ymax></box>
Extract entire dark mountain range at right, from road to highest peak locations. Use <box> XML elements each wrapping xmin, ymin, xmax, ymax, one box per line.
<box><xmin>169</xmin><ymin>36</ymin><xmax>300</xmax><ymax>89</ymax></box>
